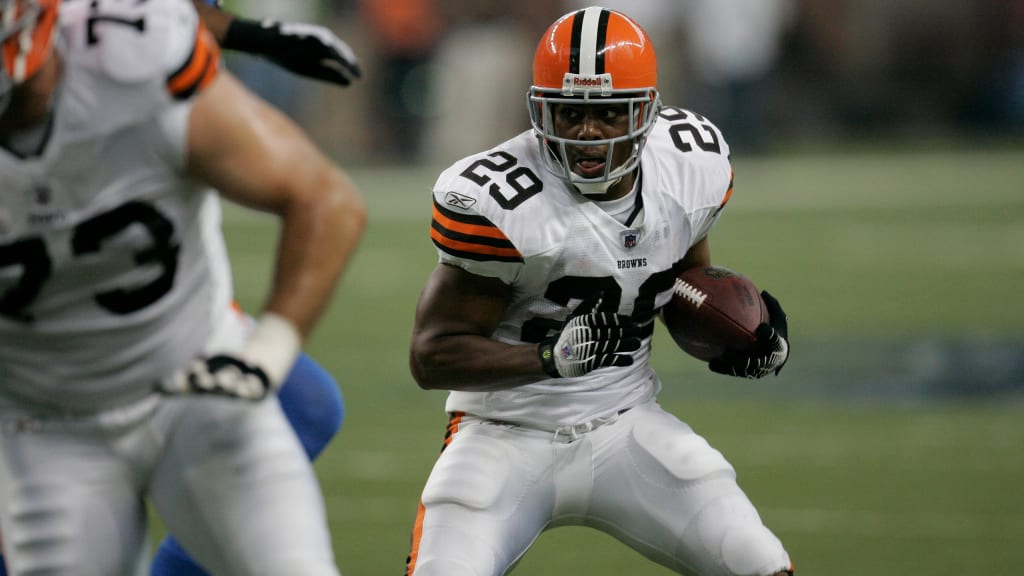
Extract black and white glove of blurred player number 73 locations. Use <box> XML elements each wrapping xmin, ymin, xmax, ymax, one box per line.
<box><xmin>158</xmin><ymin>355</ymin><xmax>270</xmax><ymax>401</ymax></box>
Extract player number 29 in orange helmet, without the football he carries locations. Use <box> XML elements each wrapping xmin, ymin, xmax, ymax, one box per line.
<box><xmin>407</xmin><ymin>7</ymin><xmax>793</xmax><ymax>576</ymax></box>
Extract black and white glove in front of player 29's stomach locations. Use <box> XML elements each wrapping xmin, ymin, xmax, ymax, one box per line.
<box><xmin>538</xmin><ymin>294</ymin><xmax>640</xmax><ymax>378</ymax></box>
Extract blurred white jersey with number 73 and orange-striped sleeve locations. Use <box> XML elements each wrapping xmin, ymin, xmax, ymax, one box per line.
<box><xmin>0</xmin><ymin>0</ymin><xmax>231</xmax><ymax>411</ymax></box>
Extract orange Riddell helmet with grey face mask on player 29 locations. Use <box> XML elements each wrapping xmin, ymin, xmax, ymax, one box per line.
<box><xmin>526</xmin><ymin>7</ymin><xmax>660</xmax><ymax>194</ymax></box>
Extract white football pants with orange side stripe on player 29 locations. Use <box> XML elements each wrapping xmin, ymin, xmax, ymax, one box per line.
<box><xmin>410</xmin><ymin>403</ymin><xmax>791</xmax><ymax>576</ymax></box>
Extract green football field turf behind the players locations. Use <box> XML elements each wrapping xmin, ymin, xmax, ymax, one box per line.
<box><xmin>214</xmin><ymin>150</ymin><xmax>1024</xmax><ymax>576</ymax></box>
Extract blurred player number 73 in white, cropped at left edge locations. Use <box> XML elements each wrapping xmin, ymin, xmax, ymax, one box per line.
<box><xmin>0</xmin><ymin>0</ymin><xmax>365</xmax><ymax>575</ymax></box>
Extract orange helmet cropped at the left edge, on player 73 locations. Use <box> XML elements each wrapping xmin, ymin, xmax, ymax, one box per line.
<box><xmin>0</xmin><ymin>0</ymin><xmax>60</xmax><ymax>112</ymax></box>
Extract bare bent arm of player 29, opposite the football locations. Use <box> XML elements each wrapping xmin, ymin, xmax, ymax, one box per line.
<box><xmin>409</xmin><ymin>264</ymin><xmax>547</xmax><ymax>390</ymax></box>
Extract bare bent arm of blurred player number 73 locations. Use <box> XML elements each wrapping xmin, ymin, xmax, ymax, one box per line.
<box><xmin>187</xmin><ymin>73</ymin><xmax>366</xmax><ymax>337</ymax></box>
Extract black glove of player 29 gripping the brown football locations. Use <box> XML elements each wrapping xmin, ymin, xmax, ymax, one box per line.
<box><xmin>708</xmin><ymin>291</ymin><xmax>790</xmax><ymax>378</ymax></box>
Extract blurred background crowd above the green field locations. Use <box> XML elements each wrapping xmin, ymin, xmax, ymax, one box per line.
<box><xmin>226</xmin><ymin>0</ymin><xmax>1024</xmax><ymax>164</ymax></box>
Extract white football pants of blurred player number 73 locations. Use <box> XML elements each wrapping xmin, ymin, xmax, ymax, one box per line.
<box><xmin>0</xmin><ymin>387</ymin><xmax>338</xmax><ymax>576</ymax></box>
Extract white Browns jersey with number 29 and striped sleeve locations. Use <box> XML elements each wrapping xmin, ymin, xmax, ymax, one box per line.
<box><xmin>430</xmin><ymin>108</ymin><xmax>732</xmax><ymax>428</ymax></box>
